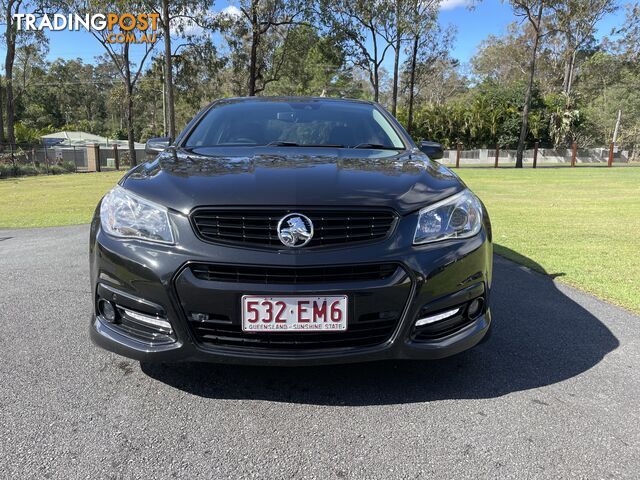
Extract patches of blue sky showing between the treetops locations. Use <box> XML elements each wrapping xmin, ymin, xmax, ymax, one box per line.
<box><xmin>0</xmin><ymin>0</ymin><xmax>624</xmax><ymax>72</ymax></box>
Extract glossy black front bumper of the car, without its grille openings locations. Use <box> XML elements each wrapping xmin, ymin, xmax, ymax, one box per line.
<box><xmin>90</xmin><ymin>208</ymin><xmax>492</xmax><ymax>365</ymax></box>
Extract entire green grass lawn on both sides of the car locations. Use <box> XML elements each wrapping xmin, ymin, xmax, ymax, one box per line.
<box><xmin>0</xmin><ymin>167</ymin><xmax>640</xmax><ymax>313</ymax></box>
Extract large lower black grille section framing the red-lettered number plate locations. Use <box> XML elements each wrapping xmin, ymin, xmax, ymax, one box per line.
<box><xmin>175</xmin><ymin>263</ymin><xmax>412</xmax><ymax>350</ymax></box>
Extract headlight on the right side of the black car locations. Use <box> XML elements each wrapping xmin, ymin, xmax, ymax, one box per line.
<box><xmin>413</xmin><ymin>190</ymin><xmax>482</xmax><ymax>244</ymax></box>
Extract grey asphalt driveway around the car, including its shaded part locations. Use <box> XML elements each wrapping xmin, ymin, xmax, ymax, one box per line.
<box><xmin>0</xmin><ymin>226</ymin><xmax>640</xmax><ymax>479</ymax></box>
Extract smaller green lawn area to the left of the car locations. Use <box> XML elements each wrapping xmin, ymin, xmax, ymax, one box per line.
<box><xmin>0</xmin><ymin>172</ymin><xmax>124</xmax><ymax>228</ymax></box>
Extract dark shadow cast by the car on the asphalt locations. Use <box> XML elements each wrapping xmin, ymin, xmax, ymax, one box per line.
<box><xmin>141</xmin><ymin>251</ymin><xmax>619</xmax><ymax>406</ymax></box>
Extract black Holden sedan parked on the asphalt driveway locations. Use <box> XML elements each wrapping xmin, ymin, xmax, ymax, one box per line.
<box><xmin>90</xmin><ymin>97</ymin><xmax>492</xmax><ymax>365</ymax></box>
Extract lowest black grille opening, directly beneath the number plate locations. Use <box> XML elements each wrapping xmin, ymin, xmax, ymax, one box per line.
<box><xmin>190</xmin><ymin>311</ymin><xmax>400</xmax><ymax>350</ymax></box>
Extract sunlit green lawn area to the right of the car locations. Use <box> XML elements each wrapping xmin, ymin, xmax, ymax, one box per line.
<box><xmin>457</xmin><ymin>167</ymin><xmax>640</xmax><ymax>312</ymax></box>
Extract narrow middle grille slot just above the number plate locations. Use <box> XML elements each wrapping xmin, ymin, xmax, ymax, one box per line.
<box><xmin>189</xmin><ymin>263</ymin><xmax>400</xmax><ymax>285</ymax></box>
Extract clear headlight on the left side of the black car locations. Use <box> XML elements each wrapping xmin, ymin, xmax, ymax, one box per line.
<box><xmin>100</xmin><ymin>186</ymin><xmax>174</xmax><ymax>243</ymax></box>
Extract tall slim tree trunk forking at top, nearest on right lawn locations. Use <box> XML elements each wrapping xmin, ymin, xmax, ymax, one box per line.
<box><xmin>510</xmin><ymin>0</ymin><xmax>548</xmax><ymax>168</ymax></box>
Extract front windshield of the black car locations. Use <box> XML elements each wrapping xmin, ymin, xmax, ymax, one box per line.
<box><xmin>184</xmin><ymin>100</ymin><xmax>405</xmax><ymax>150</ymax></box>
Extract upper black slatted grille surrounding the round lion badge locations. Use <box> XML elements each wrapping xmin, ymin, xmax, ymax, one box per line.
<box><xmin>191</xmin><ymin>208</ymin><xmax>396</xmax><ymax>248</ymax></box>
